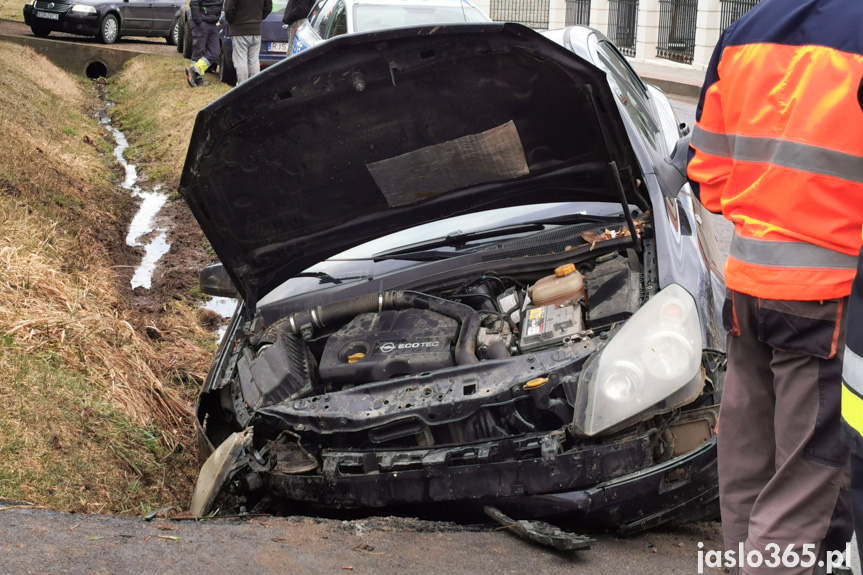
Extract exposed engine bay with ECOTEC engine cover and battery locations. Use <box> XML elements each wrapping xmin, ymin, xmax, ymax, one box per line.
<box><xmin>201</xmin><ymin>227</ymin><xmax>716</xmax><ymax>447</ymax></box>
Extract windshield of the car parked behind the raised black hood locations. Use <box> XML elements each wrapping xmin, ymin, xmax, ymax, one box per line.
<box><xmin>354</xmin><ymin>3</ymin><xmax>489</xmax><ymax>32</ymax></box>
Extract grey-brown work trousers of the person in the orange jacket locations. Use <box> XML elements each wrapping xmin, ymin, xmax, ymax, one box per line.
<box><xmin>718</xmin><ymin>290</ymin><xmax>851</xmax><ymax>575</ymax></box>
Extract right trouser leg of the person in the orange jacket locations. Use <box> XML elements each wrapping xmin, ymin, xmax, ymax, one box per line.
<box><xmin>744</xmin><ymin>300</ymin><xmax>851</xmax><ymax>575</ymax></box>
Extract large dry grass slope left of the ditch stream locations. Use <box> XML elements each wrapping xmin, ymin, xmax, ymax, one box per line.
<box><xmin>0</xmin><ymin>43</ymin><xmax>212</xmax><ymax>513</ymax></box>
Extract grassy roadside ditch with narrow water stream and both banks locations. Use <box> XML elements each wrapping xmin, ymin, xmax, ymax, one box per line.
<box><xmin>0</xmin><ymin>43</ymin><xmax>233</xmax><ymax>515</ymax></box>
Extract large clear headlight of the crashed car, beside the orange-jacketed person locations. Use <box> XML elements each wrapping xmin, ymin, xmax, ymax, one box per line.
<box><xmin>573</xmin><ymin>285</ymin><xmax>703</xmax><ymax>435</ymax></box>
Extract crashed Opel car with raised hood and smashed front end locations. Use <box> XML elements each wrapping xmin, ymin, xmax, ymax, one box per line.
<box><xmin>180</xmin><ymin>23</ymin><xmax>725</xmax><ymax>532</ymax></box>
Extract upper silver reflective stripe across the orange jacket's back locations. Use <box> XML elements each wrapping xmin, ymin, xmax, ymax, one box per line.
<box><xmin>692</xmin><ymin>126</ymin><xmax>863</xmax><ymax>184</ymax></box>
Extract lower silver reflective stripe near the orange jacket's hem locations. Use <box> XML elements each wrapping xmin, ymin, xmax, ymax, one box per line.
<box><xmin>731</xmin><ymin>231</ymin><xmax>857</xmax><ymax>270</ymax></box>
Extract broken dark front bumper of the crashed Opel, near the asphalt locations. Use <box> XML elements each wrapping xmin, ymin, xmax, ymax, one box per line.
<box><xmin>195</xmin><ymin>414</ymin><xmax>718</xmax><ymax>533</ymax></box>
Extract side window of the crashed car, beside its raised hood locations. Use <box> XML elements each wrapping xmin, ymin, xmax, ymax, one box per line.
<box><xmin>596</xmin><ymin>41</ymin><xmax>659</xmax><ymax>149</ymax></box>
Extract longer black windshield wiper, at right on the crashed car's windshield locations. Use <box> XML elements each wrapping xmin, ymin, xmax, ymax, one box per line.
<box><xmin>371</xmin><ymin>214</ymin><xmax>623</xmax><ymax>261</ymax></box>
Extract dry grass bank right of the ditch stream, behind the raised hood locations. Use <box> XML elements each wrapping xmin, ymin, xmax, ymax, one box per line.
<box><xmin>109</xmin><ymin>56</ymin><xmax>230</xmax><ymax>188</ymax></box>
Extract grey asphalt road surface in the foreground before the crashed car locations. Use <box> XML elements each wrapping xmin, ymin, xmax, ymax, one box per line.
<box><xmin>0</xmin><ymin>502</ymin><xmax>720</xmax><ymax>575</ymax></box>
